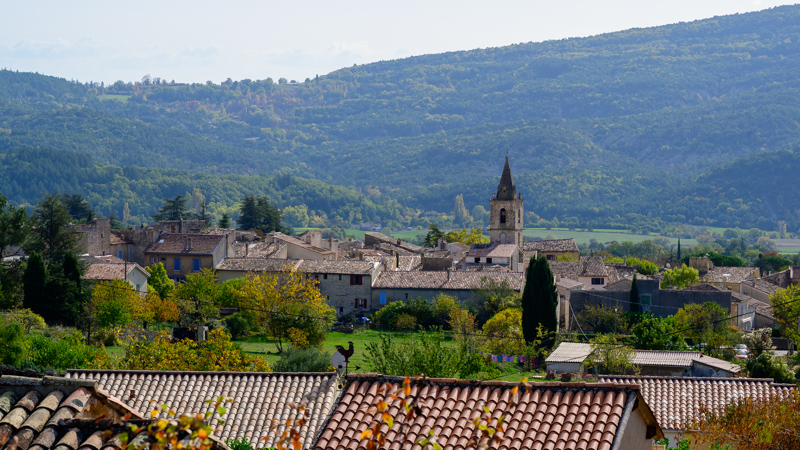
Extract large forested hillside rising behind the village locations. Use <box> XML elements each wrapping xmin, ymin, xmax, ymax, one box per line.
<box><xmin>0</xmin><ymin>6</ymin><xmax>800</xmax><ymax>231</ymax></box>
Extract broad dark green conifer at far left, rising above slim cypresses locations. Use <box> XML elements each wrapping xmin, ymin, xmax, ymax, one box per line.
<box><xmin>28</xmin><ymin>194</ymin><xmax>80</xmax><ymax>267</ymax></box>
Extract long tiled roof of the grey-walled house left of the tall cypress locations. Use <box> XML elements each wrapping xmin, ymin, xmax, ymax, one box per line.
<box><xmin>373</xmin><ymin>270</ymin><xmax>525</xmax><ymax>292</ymax></box>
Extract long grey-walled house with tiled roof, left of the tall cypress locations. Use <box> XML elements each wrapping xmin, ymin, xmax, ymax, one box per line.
<box><xmin>371</xmin><ymin>270</ymin><xmax>525</xmax><ymax>311</ymax></box>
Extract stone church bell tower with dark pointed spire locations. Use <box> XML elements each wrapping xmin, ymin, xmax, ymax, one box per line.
<box><xmin>489</xmin><ymin>156</ymin><xmax>525</xmax><ymax>246</ymax></box>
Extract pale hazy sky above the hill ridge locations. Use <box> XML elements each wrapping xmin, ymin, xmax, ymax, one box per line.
<box><xmin>0</xmin><ymin>0</ymin><xmax>794</xmax><ymax>84</ymax></box>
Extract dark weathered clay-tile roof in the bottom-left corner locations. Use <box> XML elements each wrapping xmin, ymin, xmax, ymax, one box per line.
<box><xmin>0</xmin><ymin>375</ymin><xmax>230</xmax><ymax>450</ymax></box>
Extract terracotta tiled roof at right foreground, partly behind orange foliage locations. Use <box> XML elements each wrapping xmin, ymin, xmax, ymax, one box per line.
<box><xmin>599</xmin><ymin>375</ymin><xmax>796</xmax><ymax>430</ymax></box>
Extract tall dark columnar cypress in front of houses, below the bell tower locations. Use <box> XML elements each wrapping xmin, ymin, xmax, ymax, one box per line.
<box><xmin>522</xmin><ymin>257</ymin><xmax>558</xmax><ymax>342</ymax></box>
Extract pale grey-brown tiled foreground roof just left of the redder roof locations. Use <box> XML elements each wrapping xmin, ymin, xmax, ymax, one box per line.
<box><xmin>66</xmin><ymin>370</ymin><xmax>336</xmax><ymax>448</ymax></box>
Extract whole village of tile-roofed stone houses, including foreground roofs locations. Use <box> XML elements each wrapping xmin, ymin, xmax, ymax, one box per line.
<box><xmin>0</xmin><ymin>158</ymin><xmax>800</xmax><ymax>450</ymax></box>
